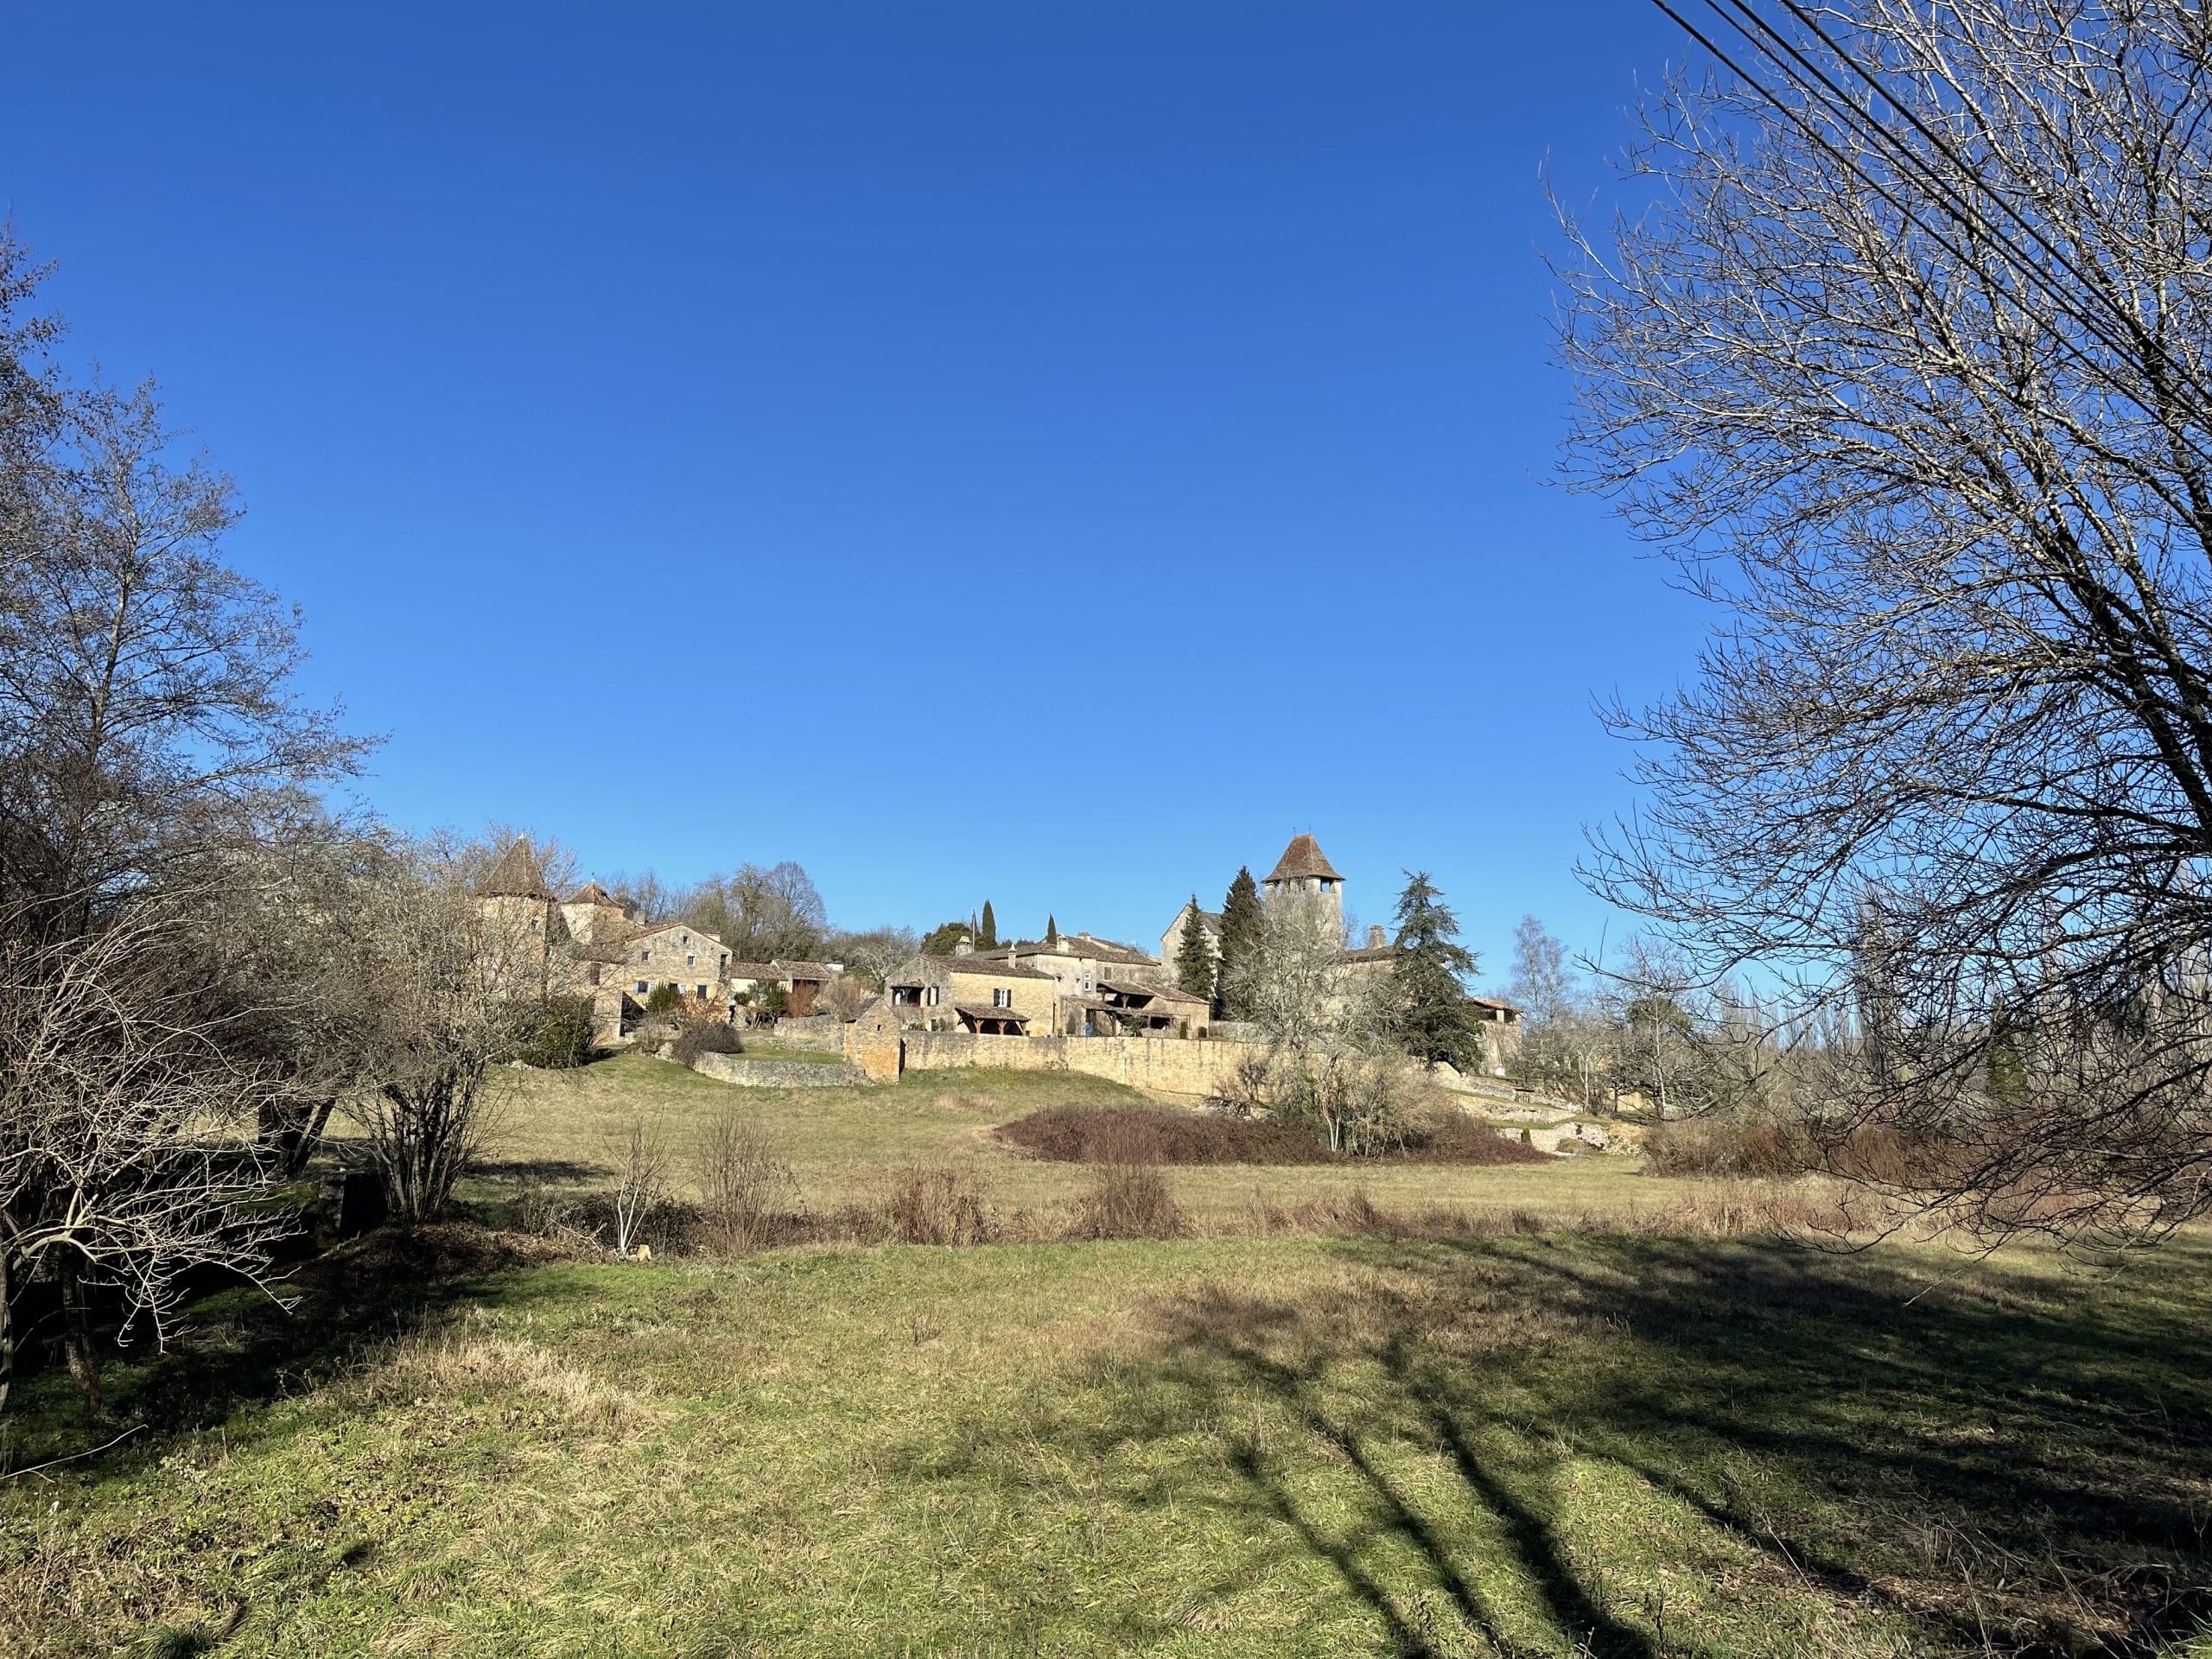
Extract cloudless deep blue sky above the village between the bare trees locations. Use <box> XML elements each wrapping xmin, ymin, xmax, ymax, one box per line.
<box><xmin>0</xmin><ymin>0</ymin><xmax>1701</xmax><ymax>980</ymax></box>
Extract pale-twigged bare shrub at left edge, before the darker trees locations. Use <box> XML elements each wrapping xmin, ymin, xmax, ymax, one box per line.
<box><xmin>0</xmin><ymin>900</ymin><xmax>289</xmax><ymax>1411</ymax></box>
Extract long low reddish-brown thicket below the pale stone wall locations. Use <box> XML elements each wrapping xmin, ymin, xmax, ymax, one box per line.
<box><xmin>993</xmin><ymin>1106</ymin><xmax>1551</xmax><ymax>1166</ymax></box>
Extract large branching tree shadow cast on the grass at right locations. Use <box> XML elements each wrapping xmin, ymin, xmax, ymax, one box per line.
<box><xmin>893</xmin><ymin>1236</ymin><xmax>2212</xmax><ymax>1659</ymax></box>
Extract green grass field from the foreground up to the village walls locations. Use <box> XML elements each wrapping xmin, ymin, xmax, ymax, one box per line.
<box><xmin>0</xmin><ymin>1062</ymin><xmax>2212</xmax><ymax>1659</ymax></box>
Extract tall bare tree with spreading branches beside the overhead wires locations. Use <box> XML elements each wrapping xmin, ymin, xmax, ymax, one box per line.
<box><xmin>1560</xmin><ymin>0</ymin><xmax>2212</xmax><ymax>1232</ymax></box>
